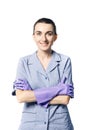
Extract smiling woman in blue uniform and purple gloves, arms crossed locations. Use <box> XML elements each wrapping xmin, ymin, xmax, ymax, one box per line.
<box><xmin>12</xmin><ymin>18</ymin><xmax>74</xmax><ymax>130</ymax></box>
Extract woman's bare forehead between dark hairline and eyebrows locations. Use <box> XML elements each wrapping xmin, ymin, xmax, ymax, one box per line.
<box><xmin>35</xmin><ymin>23</ymin><xmax>53</xmax><ymax>32</ymax></box>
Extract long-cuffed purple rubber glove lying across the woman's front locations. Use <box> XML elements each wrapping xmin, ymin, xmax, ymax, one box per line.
<box><xmin>34</xmin><ymin>83</ymin><xmax>74</xmax><ymax>107</ymax></box>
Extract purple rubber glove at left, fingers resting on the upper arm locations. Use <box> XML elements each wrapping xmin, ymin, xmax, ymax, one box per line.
<box><xmin>12</xmin><ymin>79</ymin><xmax>32</xmax><ymax>95</ymax></box>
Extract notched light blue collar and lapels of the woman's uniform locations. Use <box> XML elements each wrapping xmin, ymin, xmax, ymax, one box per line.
<box><xmin>28</xmin><ymin>51</ymin><xmax>61</xmax><ymax>74</ymax></box>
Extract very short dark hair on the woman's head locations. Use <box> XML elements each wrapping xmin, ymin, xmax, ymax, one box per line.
<box><xmin>33</xmin><ymin>18</ymin><xmax>57</xmax><ymax>35</ymax></box>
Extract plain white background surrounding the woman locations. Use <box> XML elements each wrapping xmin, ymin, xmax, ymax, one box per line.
<box><xmin>0</xmin><ymin>0</ymin><xmax>87</xmax><ymax>130</ymax></box>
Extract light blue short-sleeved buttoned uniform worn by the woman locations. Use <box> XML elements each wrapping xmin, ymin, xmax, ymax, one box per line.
<box><xmin>16</xmin><ymin>51</ymin><xmax>74</xmax><ymax>130</ymax></box>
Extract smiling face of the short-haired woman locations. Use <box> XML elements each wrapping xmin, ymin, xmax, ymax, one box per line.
<box><xmin>33</xmin><ymin>23</ymin><xmax>57</xmax><ymax>51</ymax></box>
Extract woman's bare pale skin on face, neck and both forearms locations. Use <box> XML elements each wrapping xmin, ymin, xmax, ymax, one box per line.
<box><xmin>16</xmin><ymin>23</ymin><xmax>70</xmax><ymax>105</ymax></box>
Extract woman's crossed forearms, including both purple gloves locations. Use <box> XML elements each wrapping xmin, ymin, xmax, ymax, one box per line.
<box><xmin>13</xmin><ymin>79</ymin><xmax>73</xmax><ymax>107</ymax></box>
